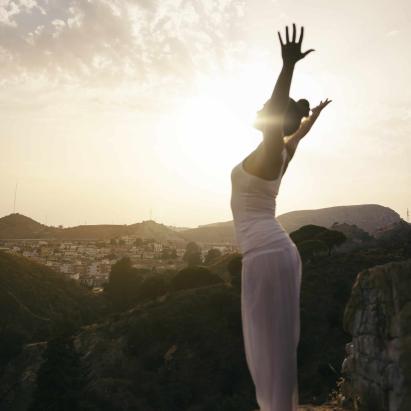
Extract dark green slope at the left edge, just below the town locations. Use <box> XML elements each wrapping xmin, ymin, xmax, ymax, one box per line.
<box><xmin>0</xmin><ymin>252</ymin><xmax>103</xmax><ymax>368</ymax></box>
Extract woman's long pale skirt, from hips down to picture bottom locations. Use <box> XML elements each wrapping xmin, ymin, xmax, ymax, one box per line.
<box><xmin>241</xmin><ymin>242</ymin><xmax>302</xmax><ymax>411</ymax></box>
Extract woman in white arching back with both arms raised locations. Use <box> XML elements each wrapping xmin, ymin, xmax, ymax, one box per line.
<box><xmin>231</xmin><ymin>24</ymin><xmax>330</xmax><ymax>411</ymax></box>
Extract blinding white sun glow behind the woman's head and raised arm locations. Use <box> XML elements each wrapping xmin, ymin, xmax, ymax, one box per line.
<box><xmin>152</xmin><ymin>62</ymin><xmax>326</xmax><ymax>192</ymax></box>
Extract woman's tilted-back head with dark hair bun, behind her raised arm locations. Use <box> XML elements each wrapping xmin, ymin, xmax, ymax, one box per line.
<box><xmin>254</xmin><ymin>98</ymin><xmax>310</xmax><ymax>136</ymax></box>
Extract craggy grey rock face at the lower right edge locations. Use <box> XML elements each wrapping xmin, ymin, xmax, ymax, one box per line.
<box><xmin>342</xmin><ymin>260</ymin><xmax>411</xmax><ymax>411</ymax></box>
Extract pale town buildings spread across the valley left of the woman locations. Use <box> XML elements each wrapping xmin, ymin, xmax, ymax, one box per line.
<box><xmin>0</xmin><ymin>236</ymin><xmax>237</xmax><ymax>292</ymax></box>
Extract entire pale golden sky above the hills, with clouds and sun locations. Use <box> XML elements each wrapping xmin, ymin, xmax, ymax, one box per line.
<box><xmin>0</xmin><ymin>0</ymin><xmax>411</xmax><ymax>227</ymax></box>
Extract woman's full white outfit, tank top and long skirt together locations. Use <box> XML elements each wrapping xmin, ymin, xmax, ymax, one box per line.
<box><xmin>231</xmin><ymin>149</ymin><xmax>302</xmax><ymax>411</ymax></box>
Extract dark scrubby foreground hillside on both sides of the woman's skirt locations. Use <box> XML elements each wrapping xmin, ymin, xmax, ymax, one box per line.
<box><xmin>0</xmin><ymin>237</ymin><xmax>411</xmax><ymax>411</ymax></box>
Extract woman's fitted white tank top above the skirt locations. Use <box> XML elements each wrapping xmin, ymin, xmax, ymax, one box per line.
<box><xmin>231</xmin><ymin>147</ymin><xmax>294</xmax><ymax>257</ymax></box>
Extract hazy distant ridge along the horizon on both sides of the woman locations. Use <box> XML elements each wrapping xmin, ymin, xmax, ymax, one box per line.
<box><xmin>0</xmin><ymin>204</ymin><xmax>403</xmax><ymax>244</ymax></box>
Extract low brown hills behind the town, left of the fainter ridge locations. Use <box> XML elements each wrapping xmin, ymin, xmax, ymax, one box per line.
<box><xmin>0</xmin><ymin>213</ymin><xmax>185</xmax><ymax>243</ymax></box>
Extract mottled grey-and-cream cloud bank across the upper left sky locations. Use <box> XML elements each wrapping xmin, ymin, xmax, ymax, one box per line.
<box><xmin>0</xmin><ymin>0</ymin><xmax>243</xmax><ymax>87</ymax></box>
